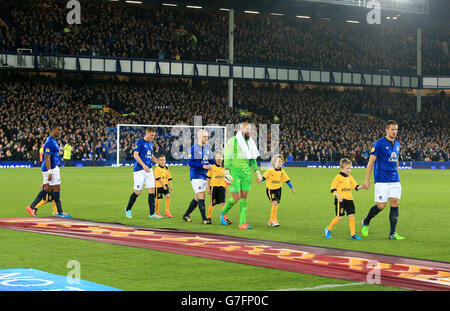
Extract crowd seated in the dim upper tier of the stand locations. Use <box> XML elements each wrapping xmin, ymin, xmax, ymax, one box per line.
<box><xmin>0</xmin><ymin>0</ymin><xmax>450</xmax><ymax>75</ymax></box>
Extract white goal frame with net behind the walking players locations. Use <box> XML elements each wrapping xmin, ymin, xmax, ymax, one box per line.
<box><xmin>107</xmin><ymin>124</ymin><xmax>227</xmax><ymax>167</ymax></box>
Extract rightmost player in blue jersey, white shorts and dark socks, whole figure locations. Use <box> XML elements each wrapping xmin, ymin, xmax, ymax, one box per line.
<box><xmin>361</xmin><ymin>120</ymin><xmax>404</xmax><ymax>240</ymax></box>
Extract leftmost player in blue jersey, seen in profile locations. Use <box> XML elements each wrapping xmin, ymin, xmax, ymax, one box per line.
<box><xmin>26</xmin><ymin>123</ymin><xmax>72</xmax><ymax>217</ymax></box>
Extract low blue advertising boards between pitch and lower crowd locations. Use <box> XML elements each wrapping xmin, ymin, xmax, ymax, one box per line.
<box><xmin>0</xmin><ymin>160</ymin><xmax>450</xmax><ymax>170</ymax></box>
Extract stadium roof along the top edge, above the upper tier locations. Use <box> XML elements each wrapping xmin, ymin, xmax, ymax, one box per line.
<box><xmin>133</xmin><ymin>0</ymin><xmax>450</xmax><ymax>26</ymax></box>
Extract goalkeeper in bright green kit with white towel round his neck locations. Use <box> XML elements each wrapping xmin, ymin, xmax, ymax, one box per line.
<box><xmin>220</xmin><ymin>122</ymin><xmax>262</xmax><ymax>229</ymax></box>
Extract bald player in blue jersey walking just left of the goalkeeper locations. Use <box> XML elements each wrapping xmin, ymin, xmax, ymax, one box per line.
<box><xmin>183</xmin><ymin>129</ymin><xmax>215</xmax><ymax>225</ymax></box>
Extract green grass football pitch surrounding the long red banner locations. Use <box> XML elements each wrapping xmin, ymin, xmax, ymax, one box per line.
<box><xmin>0</xmin><ymin>167</ymin><xmax>450</xmax><ymax>291</ymax></box>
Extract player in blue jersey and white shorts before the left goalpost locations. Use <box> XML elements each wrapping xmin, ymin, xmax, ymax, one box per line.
<box><xmin>125</xmin><ymin>127</ymin><xmax>162</xmax><ymax>219</ymax></box>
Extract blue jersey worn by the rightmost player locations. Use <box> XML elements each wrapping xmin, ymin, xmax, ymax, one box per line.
<box><xmin>370</xmin><ymin>137</ymin><xmax>400</xmax><ymax>183</ymax></box>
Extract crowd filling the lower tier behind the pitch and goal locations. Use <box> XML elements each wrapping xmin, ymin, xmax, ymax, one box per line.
<box><xmin>0</xmin><ymin>74</ymin><xmax>450</xmax><ymax>163</ymax></box>
